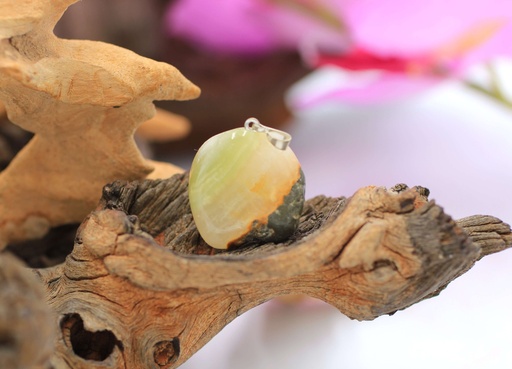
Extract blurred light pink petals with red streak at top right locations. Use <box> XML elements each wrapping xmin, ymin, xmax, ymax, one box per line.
<box><xmin>291</xmin><ymin>0</ymin><xmax>512</xmax><ymax>109</ymax></box>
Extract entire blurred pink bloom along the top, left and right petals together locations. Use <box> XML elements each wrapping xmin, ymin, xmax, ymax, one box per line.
<box><xmin>167</xmin><ymin>0</ymin><xmax>512</xmax><ymax>109</ymax></box>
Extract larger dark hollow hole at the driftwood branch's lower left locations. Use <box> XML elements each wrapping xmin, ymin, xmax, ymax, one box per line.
<box><xmin>61</xmin><ymin>314</ymin><xmax>122</xmax><ymax>361</ymax></box>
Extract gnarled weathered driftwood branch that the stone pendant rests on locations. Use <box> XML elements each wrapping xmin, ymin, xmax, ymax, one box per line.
<box><xmin>30</xmin><ymin>174</ymin><xmax>512</xmax><ymax>369</ymax></box>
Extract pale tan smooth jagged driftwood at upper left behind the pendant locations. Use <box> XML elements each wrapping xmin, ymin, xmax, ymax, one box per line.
<box><xmin>0</xmin><ymin>0</ymin><xmax>199</xmax><ymax>249</ymax></box>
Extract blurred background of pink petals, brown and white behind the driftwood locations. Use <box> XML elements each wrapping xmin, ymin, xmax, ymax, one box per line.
<box><xmin>28</xmin><ymin>0</ymin><xmax>512</xmax><ymax>369</ymax></box>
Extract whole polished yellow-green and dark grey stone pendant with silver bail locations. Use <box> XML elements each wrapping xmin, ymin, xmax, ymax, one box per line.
<box><xmin>189</xmin><ymin>118</ymin><xmax>305</xmax><ymax>249</ymax></box>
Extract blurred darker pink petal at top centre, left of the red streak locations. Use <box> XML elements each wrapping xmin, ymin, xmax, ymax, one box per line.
<box><xmin>165</xmin><ymin>0</ymin><xmax>346</xmax><ymax>56</ymax></box>
